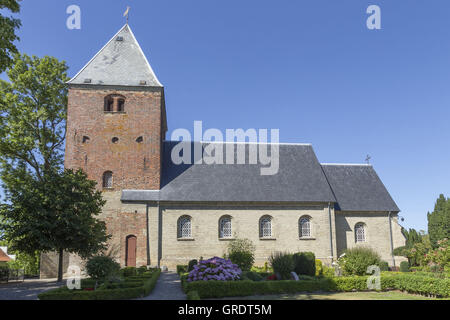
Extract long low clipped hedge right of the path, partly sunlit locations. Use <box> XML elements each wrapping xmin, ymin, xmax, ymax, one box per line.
<box><xmin>182</xmin><ymin>274</ymin><xmax>450</xmax><ymax>299</ymax></box>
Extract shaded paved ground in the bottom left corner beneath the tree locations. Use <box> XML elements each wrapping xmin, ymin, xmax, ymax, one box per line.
<box><xmin>0</xmin><ymin>279</ymin><xmax>61</xmax><ymax>300</ymax></box>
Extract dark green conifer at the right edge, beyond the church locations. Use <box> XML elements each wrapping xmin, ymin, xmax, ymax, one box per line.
<box><xmin>427</xmin><ymin>194</ymin><xmax>450</xmax><ymax>248</ymax></box>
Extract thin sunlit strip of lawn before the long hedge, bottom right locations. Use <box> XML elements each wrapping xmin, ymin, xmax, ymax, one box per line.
<box><xmin>217</xmin><ymin>291</ymin><xmax>438</xmax><ymax>300</ymax></box>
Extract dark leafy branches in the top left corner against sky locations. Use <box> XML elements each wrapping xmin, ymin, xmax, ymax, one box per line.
<box><xmin>0</xmin><ymin>0</ymin><xmax>21</xmax><ymax>73</ymax></box>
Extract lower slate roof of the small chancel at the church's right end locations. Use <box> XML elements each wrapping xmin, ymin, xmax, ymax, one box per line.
<box><xmin>322</xmin><ymin>164</ymin><xmax>400</xmax><ymax>212</ymax></box>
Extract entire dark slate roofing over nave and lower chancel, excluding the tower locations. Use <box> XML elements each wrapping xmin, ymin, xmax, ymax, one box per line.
<box><xmin>122</xmin><ymin>141</ymin><xmax>400</xmax><ymax>212</ymax></box>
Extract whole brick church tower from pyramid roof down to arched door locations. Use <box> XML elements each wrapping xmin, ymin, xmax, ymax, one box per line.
<box><xmin>36</xmin><ymin>24</ymin><xmax>167</xmax><ymax>272</ymax></box>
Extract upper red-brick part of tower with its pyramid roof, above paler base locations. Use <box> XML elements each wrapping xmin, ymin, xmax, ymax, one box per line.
<box><xmin>65</xmin><ymin>24</ymin><xmax>167</xmax><ymax>192</ymax></box>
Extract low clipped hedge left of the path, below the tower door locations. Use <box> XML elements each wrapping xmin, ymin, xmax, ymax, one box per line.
<box><xmin>38</xmin><ymin>269</ymin><xmax>161</xmax><ymax>300</ymax></box>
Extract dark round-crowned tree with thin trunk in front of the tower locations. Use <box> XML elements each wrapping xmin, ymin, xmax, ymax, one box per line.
<box><xmin>0</xmin><ymin>169</ymin><xmax>110</xmax><ymax>281</ymax></box>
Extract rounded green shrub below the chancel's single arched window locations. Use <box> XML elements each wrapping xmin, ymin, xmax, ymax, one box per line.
<box><xmin>339</xmin><ymin>247</ymin><xmax>381</xmax><ymax>276</ymax></box>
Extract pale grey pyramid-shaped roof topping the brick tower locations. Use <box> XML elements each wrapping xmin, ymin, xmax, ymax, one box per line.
<box><xmin>68</xmin><ymin>24</ymin><xmax>162</xmax><ymax>87</ymax></box>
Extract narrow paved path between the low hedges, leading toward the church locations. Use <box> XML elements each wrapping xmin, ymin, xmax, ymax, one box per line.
<box><xmin>140</xmin><ymin>272</ymin><xmax>186</xmax><ymax>300</ymax></box>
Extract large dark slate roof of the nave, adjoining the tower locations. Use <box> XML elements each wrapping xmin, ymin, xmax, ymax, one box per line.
<box><xmin>122</xmin><ymin>141</ymin><xmax>335</xmax><ymax>202</ymax></box>
